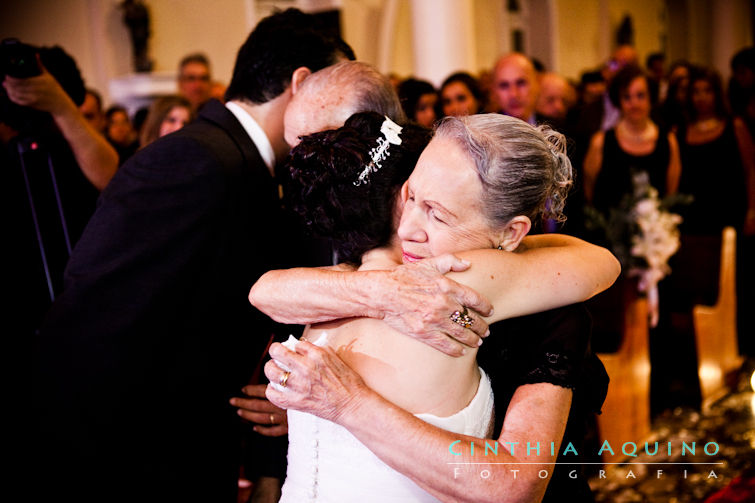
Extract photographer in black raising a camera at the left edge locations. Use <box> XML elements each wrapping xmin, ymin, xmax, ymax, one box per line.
<box><xmin>0</xmin><ymin>40</ymin><xmax>118</xmax><ymax>335</ymax></box>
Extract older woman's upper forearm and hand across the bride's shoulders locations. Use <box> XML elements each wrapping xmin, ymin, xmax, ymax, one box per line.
<box><xmin>249</xmin><ymin>262</ymin><xmax>492</xmax><ymax>356</ymax></box>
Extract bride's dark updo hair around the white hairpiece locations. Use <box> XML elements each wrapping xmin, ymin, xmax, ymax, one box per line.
<box><xmin>286</xmin><ymin>112</ymin><xmax>431</xmax><ymax>264</ymax></box>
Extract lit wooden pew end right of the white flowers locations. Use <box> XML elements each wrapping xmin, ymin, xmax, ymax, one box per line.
<box><xmin>693</xmin><ymin>227</ymin><xmax>742</xmax><ymax>407</ymax></box>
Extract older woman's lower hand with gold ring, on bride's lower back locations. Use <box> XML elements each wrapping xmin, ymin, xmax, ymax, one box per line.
<box><xmin>265</xmin><ymin>341</ymin><xmax>370</xmax><ymax>424</ymax></box>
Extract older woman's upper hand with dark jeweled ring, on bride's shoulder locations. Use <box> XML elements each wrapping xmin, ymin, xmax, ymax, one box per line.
<box><xmin>380</xmin><ymin>254</ymin><xmax>493</xmax><ymax>356</ymax></box>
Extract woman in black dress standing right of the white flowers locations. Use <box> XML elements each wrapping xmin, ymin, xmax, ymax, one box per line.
<box><xmin>651</xmin><ymin>67</ymin><xmax>755</xmax><ymax>413</ymax></box>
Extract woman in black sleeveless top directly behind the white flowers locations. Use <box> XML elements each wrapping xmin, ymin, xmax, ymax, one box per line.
<box><xmin>584</xmin><ymin>66</ymin><xmax>681</xmax><ymax>213</ymax></box>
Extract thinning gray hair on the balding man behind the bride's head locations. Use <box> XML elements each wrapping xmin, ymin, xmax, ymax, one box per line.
<box><xmin>301</xmin><ymin>61</ymin><xmax>406</xmax><ymax>124</ymax></box>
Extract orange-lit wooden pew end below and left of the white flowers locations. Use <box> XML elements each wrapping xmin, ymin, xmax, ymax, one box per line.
<box><xmin>588</xmin><ymin>279</ymin><xmax>650</xmax><ymax>462</ymax></box>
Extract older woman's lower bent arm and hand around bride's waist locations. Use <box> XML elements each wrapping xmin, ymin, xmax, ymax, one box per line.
<box><xmin>265</xmin><ymin>342</ymin><xmax>572</xmax><ymax>503</ymax></box>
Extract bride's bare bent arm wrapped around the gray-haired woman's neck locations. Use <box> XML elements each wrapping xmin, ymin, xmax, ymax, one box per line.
<box><xmin>447</xmin><ymin>234</ymin><xmax>621</xmax><ymax>323</ymax></box>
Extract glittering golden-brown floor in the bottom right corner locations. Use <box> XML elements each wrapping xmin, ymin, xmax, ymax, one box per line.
<box><xmin>590</xmin><ymin>369</ymin><xmax>755</xmax><ymax>503</ymax></box>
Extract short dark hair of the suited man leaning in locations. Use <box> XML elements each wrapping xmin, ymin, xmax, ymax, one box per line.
<box><xmin>225</xmin><ymin>9</ymin><xmax>354</xmax><ymax>104</ymax></box>
